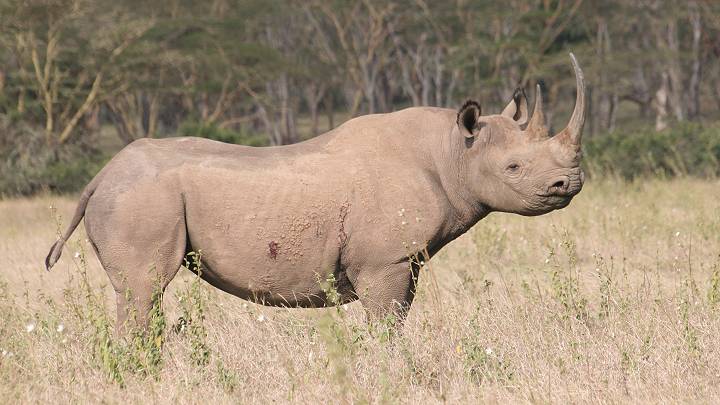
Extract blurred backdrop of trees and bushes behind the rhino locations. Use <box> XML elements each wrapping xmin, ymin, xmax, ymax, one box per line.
<box><xmin>0</xmin><ymin>0</ymin><xmax>720</xmax><ymax>196</ymax></box>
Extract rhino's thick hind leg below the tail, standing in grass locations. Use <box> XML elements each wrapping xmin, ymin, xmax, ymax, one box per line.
<box><xmin>86</xmin><ymin>188</ymin><xmax>187</xmax><ymax>336</ymax></box>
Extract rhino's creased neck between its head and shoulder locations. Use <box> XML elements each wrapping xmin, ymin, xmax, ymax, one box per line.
<box><xmin>432</xmin><ymin>115</ymin><xmax>491</xmax><ymax>243</ymax></box>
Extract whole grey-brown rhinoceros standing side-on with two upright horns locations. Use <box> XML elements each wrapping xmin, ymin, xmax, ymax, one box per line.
<box><xmin>45</xmin><ymin>54</ymin><xmax>585</xmax><ymax>329</ymax></box>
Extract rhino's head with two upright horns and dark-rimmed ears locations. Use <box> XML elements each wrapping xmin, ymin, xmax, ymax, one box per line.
<box><xmin>454</xmin><ymin>54</ymin><xmax>585</xmax><ymax>215</ymax></box>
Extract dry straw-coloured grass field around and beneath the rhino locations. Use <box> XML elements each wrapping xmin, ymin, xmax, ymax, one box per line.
<box><xmin>0</xmin><ymin>179</ymin><xmax>720</xmax><ymax>403</ymax></box>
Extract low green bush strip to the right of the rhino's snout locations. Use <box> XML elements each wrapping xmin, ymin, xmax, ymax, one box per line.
<box><xmin>583</xmin><ymin>123</ymin><xmax>720</xmax><ymax>180</ymax></box>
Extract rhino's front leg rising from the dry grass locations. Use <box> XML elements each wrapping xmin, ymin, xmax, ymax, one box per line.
<box><xmin>353</xmin><ymin>262</ymin><xmax>419</xmax><ymax>327</ymax></box>
